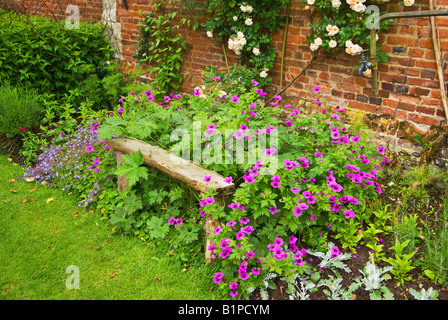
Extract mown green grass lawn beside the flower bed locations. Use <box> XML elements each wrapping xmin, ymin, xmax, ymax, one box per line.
<box><xmin>0</xmin><ymin>154</ymin><xmax>222</xmax><ymax>300</ymax></box>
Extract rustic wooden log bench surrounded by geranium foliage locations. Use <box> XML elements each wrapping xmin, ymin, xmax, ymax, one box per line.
<box><xmin>108</xmin><ymin>138</ymin><xmax>235</xmax><ymax>264</ymax></box>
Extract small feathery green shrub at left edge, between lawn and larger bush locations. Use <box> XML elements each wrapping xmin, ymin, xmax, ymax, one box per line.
<box><xmin>0</xmin><ymin>83</ymin><xmax>43</xmax><ymax>138</ymax></box>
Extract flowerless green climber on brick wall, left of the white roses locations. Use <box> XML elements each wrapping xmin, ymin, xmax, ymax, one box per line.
<box><xmin>134</xmin><ymin>3</ymin><xmax>187</xmax><ymax>92</ymax></box>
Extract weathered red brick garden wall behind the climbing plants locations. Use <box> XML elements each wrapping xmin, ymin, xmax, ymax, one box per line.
<box><xmin>9</xmin><ymin>0</ymin><xmax>448</xmax><ymax>153</ymax></box>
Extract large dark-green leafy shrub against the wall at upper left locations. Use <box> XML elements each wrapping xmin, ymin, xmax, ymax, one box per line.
<box><xmin>0</xmin><ymin>11</ymin><xmax>121</xmax><ymax>108</ymax></box>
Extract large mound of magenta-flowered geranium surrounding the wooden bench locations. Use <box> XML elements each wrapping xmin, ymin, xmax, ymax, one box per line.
<box><xmin>21</xmin><ymin>77</ymin><xmax>448</xmax><ymax>299</ymax></box>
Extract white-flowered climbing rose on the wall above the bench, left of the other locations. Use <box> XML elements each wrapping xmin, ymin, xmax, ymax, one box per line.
<box><xmin>192</xmin><ymin>0</ymin><xmax>289</xmax><ymax>86</ymax></box>
